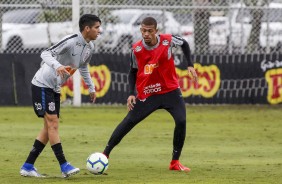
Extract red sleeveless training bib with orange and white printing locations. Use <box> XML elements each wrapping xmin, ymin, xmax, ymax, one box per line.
<box><xmin>133</xmin><ymin>34</ymin><xmax>179</xmax><ymax>100</ymax></box>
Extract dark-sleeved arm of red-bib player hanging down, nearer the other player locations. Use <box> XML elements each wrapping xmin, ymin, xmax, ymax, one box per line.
<box><xmin>127</xmin><ymin>51</ymin><xmax>138</xmax><ymax>110</ymax></box>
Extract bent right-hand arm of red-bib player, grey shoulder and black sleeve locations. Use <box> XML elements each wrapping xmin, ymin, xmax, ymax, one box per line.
<box><xmin>172</xmin><ymin>35</ymin><xmax>198</xmax><ymax>82</ymax></box>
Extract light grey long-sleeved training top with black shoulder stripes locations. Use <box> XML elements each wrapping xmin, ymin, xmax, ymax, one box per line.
<box><xmin>31</xmin><ymin>33</ymin><xmax>95</xmax><ymax>93</ymax></box>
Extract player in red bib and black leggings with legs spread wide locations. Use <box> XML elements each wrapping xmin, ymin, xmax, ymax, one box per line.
<box><xmin>103</xmin><ymin>17</ymin><xmax>198</xmax><ymax>172</ymax></box>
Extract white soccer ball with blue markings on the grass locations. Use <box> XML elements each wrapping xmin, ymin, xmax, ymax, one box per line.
<box><xmin>86</xmin><ymin>152</ymin><xmax>109</xmax><ymax>174</ymax></box>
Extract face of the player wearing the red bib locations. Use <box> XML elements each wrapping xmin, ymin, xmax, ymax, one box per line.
<box><xmin>140</xmin><ymin>24</ymin><xmax>158</xmax><ymax>46</ymax></box>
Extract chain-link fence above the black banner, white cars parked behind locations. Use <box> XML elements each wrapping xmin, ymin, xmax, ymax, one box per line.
<box><xmin>0</xmin><ymin>0</ymin><xmax>282</xmax><ymax>54</ymax></box>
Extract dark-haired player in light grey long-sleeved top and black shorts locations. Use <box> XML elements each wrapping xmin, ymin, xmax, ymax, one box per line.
<box><xmin>20</xmin><ymin>14</ymin><xmax>101</xmax><ymax>178</ymax></box>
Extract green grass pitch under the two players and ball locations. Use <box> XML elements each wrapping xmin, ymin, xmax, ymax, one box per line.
<box><xmin>0</xmin><ymin>106</ymin><xmax>282</xmax><ymax>184</ymax></box>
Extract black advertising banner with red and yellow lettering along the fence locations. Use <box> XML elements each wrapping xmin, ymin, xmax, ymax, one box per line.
<box><xmin>0</xmin><ymin>54</ymin><xmax>282</xmax><ymax>105</ymax></box>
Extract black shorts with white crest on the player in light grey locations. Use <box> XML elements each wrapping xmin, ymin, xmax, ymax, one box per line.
<box><xmin>31</xmin><ymin>85</ymin><xmax>60</xmax><ymax>118</ymax></box>
